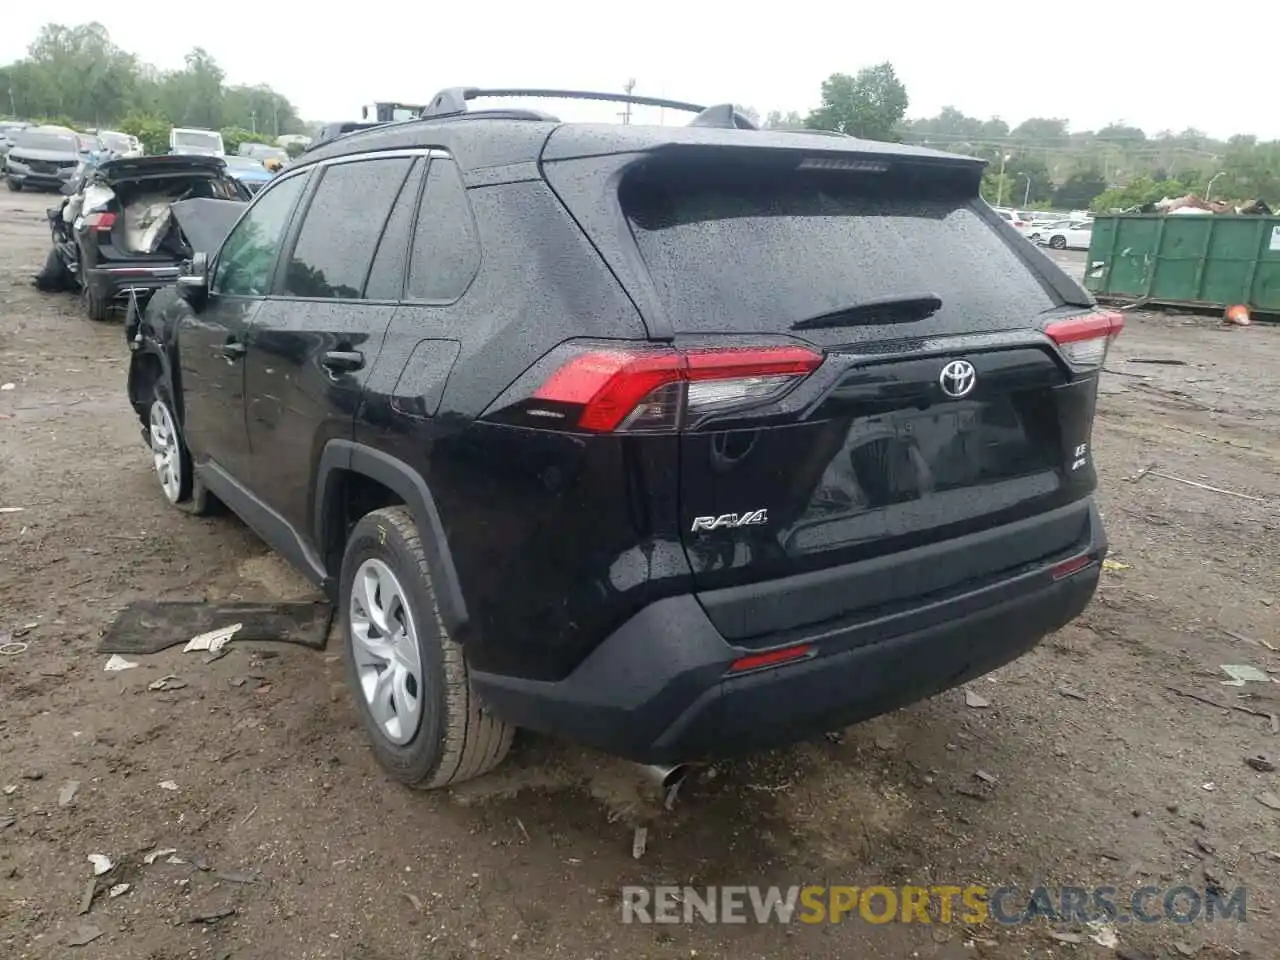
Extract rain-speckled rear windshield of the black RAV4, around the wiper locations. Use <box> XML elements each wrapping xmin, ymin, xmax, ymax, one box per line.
<box><xmin>620</xmin><ymin>165</ymin><xmax>1060</xmax><ymax>339</ymax></box>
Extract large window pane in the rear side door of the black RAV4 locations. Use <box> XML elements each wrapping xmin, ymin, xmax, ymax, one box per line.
<box><xmin>283</xmin><ymin>156</ymin><xmax>413</xmax><ymax>300</ymax></box>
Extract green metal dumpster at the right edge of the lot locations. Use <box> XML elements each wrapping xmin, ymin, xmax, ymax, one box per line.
<box><xmin>1084</xmin><ymin>214</ymin><xmax>1280</xmax><ymax>314</ymax></box>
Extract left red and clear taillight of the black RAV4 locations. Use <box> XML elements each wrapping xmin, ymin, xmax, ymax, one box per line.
<box><xmin>485</xmin><ymin>343</ymin><xmax>822</xmax><ymax>433</ymax></box>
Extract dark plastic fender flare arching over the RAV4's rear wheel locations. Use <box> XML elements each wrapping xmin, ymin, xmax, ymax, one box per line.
<box><xmin>312</xmin><ymin>440</ymin><xmax>470</xmax><ymax>641</ymax></box>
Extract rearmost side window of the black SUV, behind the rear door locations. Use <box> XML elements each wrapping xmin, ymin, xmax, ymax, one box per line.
<box><xmin>408</xmin><ymin>159</ymin><xmax>480</xmax><ymax>303</ymax></box>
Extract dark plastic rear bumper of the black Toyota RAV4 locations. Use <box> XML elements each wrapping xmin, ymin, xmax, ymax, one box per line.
<box><xmin>471</xmin><ymin>504</ymin><xmax>1106</xmax><ymax>763</ymax></box>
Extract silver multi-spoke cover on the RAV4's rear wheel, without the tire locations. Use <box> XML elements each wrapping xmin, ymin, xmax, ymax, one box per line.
<box><xmin>348</xmin><ymin>559</ymin><xmax>422</xmax><ymax>744</ymax></box>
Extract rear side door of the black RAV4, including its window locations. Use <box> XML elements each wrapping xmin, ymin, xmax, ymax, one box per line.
<box><xmin>246</xmin><ymin>154</ymin><xmax>425</xmax><ymax>541</ymax></box>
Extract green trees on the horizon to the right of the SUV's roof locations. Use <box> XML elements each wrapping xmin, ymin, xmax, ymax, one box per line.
<box><xmin>748</xmin><ymin>63</ymin><xmax>1280</xmax><ymax>211</ymax></box>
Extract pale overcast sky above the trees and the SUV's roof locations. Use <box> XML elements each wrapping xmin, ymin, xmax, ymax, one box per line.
<box><xmin>0</xmin><ymin>0</ymin><xmax>1280</xmax><ymax>140</ymax></box>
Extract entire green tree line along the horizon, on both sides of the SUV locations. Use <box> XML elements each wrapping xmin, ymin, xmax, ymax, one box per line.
<box><xmin>0</xmin><ymin>23</ymin><xmax>1280</xmax><ymax>210</ymax></box>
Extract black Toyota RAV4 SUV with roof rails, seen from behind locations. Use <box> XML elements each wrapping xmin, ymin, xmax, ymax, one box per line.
<box><xmin>129</xmin><ymin>90</ymin><xmax>1123</xmax><ymax>786</ymax></box>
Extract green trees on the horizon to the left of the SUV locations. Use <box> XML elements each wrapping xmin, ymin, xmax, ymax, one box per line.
<box><xmin>0</xmin><ymin>23</ymin><xmax>307</xmax><ymax>152</ymax></box>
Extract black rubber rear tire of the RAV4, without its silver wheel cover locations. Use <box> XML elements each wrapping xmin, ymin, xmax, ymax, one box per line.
<box><xmin>339</xmin><ymin>507</ymin><xmax>515</xmax><ymax>790</ymax></box>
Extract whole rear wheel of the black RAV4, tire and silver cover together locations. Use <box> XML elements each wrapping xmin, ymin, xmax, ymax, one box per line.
<box><xmin>339</xmin><ymin>507</ymin><xmax>515</xmax><ymax>790</ymax></box>
